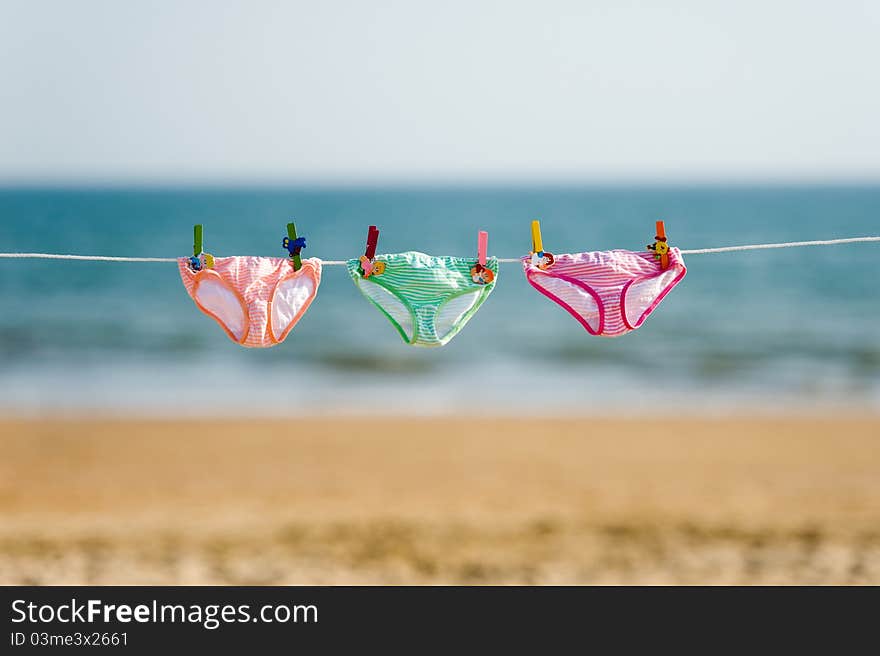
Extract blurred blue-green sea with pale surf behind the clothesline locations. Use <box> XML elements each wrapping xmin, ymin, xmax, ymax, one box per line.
<box><xmin>0</xmin><ymin>187</ymin><xmax>880</xmax><ymax>416</ymax></box>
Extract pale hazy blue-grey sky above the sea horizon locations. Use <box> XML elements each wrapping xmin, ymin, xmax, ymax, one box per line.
<box><xmin>0</xmin><ymin>0</ymin><xmax>880</xmax><ymax>185</ymax></box>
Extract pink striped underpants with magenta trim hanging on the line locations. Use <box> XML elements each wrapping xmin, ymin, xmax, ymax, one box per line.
<box><xmin>523</xmin><ymin>248</ymin><xmax>687</xmax><ymax>337</ymax></box>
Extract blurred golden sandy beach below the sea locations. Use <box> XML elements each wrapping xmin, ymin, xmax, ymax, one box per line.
<box><xmin>0</xmin><ymin>416</ymin><xmax>880</xmax><ymax>584</ymax></box>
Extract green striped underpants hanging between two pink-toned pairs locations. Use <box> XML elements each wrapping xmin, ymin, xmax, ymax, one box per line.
<box><xmin>347</xmin><ymin>251</ymin><xmax>498</xmax><ymax>346</ymax></box>
